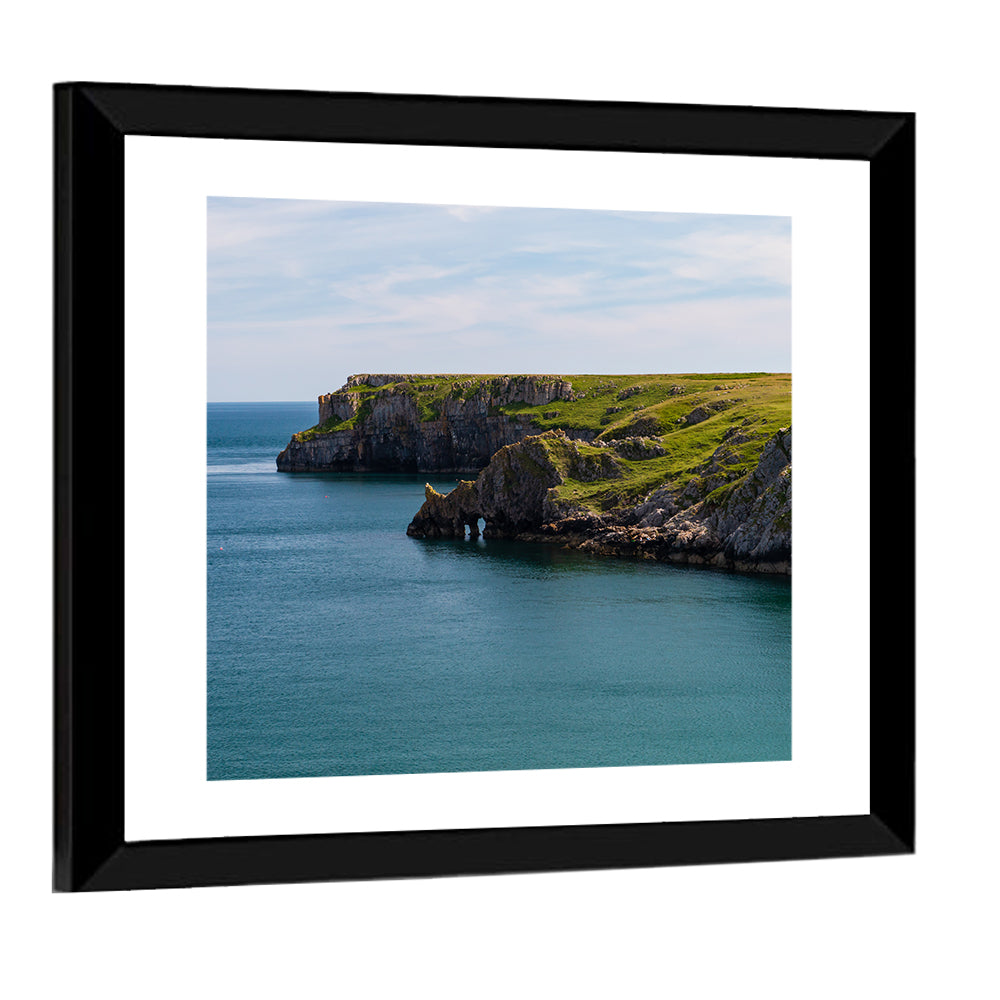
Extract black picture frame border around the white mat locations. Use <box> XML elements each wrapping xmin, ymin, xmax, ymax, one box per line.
<box><xmin>54</xmin><ymin>83</ymin><xmax>915</xmax><ymax>891</ymax></box>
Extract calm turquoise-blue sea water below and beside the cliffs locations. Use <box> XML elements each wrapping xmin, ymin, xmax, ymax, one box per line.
<box><xmin>208</xmin><ymin>403</ymin><xmax>791</xmax><ymax>779</ymax></box>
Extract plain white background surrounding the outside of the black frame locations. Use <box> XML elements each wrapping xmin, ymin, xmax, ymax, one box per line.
<box><xmin>0</xmin><ymin>0</ymin><xmax>998</xmax><ymax>997</ymax></box>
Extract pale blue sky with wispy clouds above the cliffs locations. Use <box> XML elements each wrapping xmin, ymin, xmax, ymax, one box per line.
<box><xmin>208</xmin><ymin>198</ymin><xmax>791</xmax><ymax>401</ymax></box>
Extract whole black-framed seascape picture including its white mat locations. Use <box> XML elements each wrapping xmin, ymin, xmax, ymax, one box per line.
<box><xmin>54</xmin><ymin>83</ymin><xmax>915</xmax><ymax>891</ymax></box>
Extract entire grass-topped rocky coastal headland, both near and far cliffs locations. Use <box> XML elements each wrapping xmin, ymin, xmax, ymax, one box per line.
<box><xmin>277</xmin><ymin>372</ymin><xmax>791</xmax><ymax>574</ymax></box>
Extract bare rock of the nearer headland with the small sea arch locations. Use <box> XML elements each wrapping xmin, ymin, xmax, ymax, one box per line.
<box><xmin>407</xmin><ymin>428</ymin><xmax>792</xmax><ymax>574</ymax></box>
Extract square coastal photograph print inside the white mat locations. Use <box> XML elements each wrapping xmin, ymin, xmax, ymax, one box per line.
<box><xmin>207</xmin><ymin>197</ymin><xmax>792</xmax><ymax>781</ymax></box>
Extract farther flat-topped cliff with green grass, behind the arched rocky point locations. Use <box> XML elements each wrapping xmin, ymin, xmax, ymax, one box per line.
<box><xmin>277</xmin><ymin>372</ymin><xmax>791</xmax><ymax>480</ymax></box>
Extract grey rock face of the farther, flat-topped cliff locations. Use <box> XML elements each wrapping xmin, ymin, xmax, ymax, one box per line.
<box><xmin>277</xmin><ymin>375</ymin><xmax>594</xmax><ymax>472</ymax></box>
